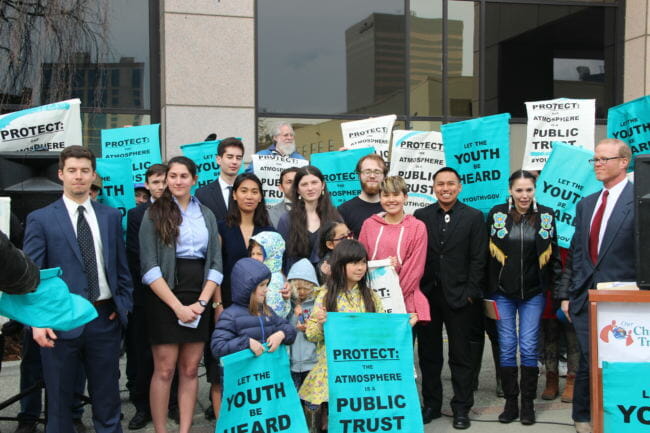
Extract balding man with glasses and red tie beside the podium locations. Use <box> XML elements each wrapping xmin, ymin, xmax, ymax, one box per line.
<box><xmin>557</xmin><ymin>138</ymin><xmax>636</xmax><ymax>433</ymax></box>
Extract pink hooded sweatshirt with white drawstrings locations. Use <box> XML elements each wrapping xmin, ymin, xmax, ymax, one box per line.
<box><xmin>359</xmin><ymin>213</ymin><xmax>431</xmax><ymax>322</ymax></box>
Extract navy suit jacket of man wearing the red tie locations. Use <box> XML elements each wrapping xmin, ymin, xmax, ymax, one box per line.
<box><xmin>559</xmin><ymin>181</ymin><xmax>636</xmax><ymax>314</ymax></box>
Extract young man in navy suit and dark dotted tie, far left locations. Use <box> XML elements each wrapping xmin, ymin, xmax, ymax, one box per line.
<box><xmin>24</xmin><ymin>146</ymin><xmax>133</xmax><ymax>433</ymax></box>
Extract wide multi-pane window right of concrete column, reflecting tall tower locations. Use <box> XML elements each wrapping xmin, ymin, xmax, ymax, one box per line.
<box><xmin>256</xmin><ymin>0</ymin><xmax>624</xmax><ymax>148</ymax></box>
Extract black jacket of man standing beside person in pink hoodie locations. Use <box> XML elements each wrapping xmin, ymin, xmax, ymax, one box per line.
<box><xmin>413</xmin><ymin>201</ymin><xmax>488</xmax><ymax>308</ymax></box>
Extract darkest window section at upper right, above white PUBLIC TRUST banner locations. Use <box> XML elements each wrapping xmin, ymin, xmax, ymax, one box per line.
<box><xmin>485</xmin><ymin>3</ymin><xmax>617</xmax><ymax>119</ymax></box>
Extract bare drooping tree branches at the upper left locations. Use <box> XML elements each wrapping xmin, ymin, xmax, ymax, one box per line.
<box><xmin>0</xmin><ymin>0</ymin><xmax>110</xmax><ymax>106</ymax></box>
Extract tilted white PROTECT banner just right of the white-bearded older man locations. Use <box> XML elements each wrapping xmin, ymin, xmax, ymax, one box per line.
<box><xmin>341</xmin><ymin>114</ymin><xmax>397</xmax><ymax>161</ymax></box>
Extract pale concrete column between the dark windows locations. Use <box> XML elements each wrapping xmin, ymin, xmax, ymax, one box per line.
<box><xmin>160</xmin><ymin>0</ymin><xmax>255</xmax><ymax>160</ymax></box>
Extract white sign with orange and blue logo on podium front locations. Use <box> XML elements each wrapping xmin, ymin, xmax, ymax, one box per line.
<box><xmin>597</xmin><ymin>302</ymin><xmax>650</xmax><ymax>366</ymax></box>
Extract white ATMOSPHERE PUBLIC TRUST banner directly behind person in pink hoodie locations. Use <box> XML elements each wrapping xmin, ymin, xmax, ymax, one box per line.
<box><xmin>388</xmin><ymin>130</ymin><xmax>445</xmax><ymax>214</ymax></box>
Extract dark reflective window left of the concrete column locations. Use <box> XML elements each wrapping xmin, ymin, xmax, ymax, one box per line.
<box><xmin>0</xmin><ymin>0</ymin><xmax>151</xmax><ymax>155</ymax></box>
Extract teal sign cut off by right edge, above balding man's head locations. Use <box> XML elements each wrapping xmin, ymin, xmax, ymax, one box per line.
<box><xmin>607</xmin><ymin>95</ymin><xmax>650</xmax><ymax>171</ymax></box>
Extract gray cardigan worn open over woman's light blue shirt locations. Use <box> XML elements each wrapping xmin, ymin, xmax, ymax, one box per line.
<box><xmin>139</xmin><ymin>204</ymin><xmax>223</xmax><ymax>290</ymax></box>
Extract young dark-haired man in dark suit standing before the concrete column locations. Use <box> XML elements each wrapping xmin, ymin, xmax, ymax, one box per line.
<box><xmin>195</xmin><ymin>137</ymin><xmax>244</xmax><ymax>221</ymax></box>
